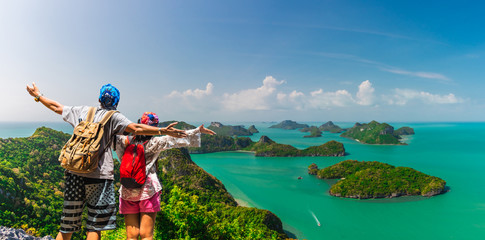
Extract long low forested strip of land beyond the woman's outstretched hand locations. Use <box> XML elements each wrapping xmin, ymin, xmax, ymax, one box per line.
<box><xmin>189</xmin><ymin>135</ymin><xmax>345</xmax><ymax>157</ymax></box>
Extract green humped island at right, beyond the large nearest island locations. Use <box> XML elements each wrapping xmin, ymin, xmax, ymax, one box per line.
<box><xmin>340</xmin><ymin>121</ymin><xmax>414</xmax><ymax>145</ymax></box>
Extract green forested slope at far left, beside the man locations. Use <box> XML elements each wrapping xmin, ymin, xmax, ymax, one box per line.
<box><xmin>0</xmin><ymin>127</ymin><xmax>70</xmax><ymax>236</ymax></box>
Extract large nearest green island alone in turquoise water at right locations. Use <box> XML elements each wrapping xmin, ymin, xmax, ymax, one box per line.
<box><xmin>308</xmin><ymin>160</ymin><xmax>446</xmax><ymax>199</ymax></box>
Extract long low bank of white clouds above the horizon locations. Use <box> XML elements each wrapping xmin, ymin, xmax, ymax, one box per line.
<box><xmin>164</xmin><ymin>76</ymin><xmax>464</xmax><ymax>116</ymax></box>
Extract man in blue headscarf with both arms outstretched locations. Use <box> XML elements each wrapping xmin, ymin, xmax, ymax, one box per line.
<box><xmin>27</xmin><ymin>83</ymin><xmax>186</xmax><ymax>240</ymax></box>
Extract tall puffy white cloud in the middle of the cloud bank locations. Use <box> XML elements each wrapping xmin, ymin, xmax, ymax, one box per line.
<box><xmin>222</xmin><ymin>76</ymin><xmax>285</xmax><ymax>111</ymax></box>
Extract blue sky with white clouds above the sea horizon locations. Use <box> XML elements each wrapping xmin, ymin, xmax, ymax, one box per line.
<box><xmin>0</xmin><ymin>0</ymin><xmax>485</xmax><ymax>122</ymax></box>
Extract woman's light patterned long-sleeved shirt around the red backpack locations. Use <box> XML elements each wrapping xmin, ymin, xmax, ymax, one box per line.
<box><xmin>116</xmin><ymin>128</ymin><xmax>200</xmax><ymax>201</ymax></box>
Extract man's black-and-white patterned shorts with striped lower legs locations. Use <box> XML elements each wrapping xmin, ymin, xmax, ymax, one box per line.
<box><xmin>60</xmin><ymin>171</ymin><xmax>116</xmax><ymax>233</ymax></box>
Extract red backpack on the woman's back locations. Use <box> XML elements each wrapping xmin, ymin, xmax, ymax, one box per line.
<box><xmin>120</xmin><ymin>137</ymin><xmax>148</xmax><ymax>188</ymax></box>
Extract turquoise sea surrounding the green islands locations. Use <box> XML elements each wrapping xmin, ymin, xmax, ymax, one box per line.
<box><xmin>0</xmin><ymin>122</ymin><xmax>485</xmax><ymax>240</ymax></box>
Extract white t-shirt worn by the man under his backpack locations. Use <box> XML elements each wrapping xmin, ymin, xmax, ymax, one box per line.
<box><xmin>62</xmin><ymin>106</ymin><xmax>132</xmax><ymax>180</ymax></box>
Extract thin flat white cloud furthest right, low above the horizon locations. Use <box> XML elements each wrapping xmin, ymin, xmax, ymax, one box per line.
<box><xmin>387</xmin><ymin>89</ymin><xmax>464</xmax><ymax>105</ymax></box>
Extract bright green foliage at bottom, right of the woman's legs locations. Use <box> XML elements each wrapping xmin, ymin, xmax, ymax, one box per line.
<box><xmin>155</xmin><ymin>186</ymin><xmax>286</xmax><ymax>239</ymax></box>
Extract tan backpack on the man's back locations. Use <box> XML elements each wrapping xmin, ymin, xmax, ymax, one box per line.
<box><xmin>59</xmin><ymin>107</ymin><xmax>117</xmax><ymax>173</ymax></box>
